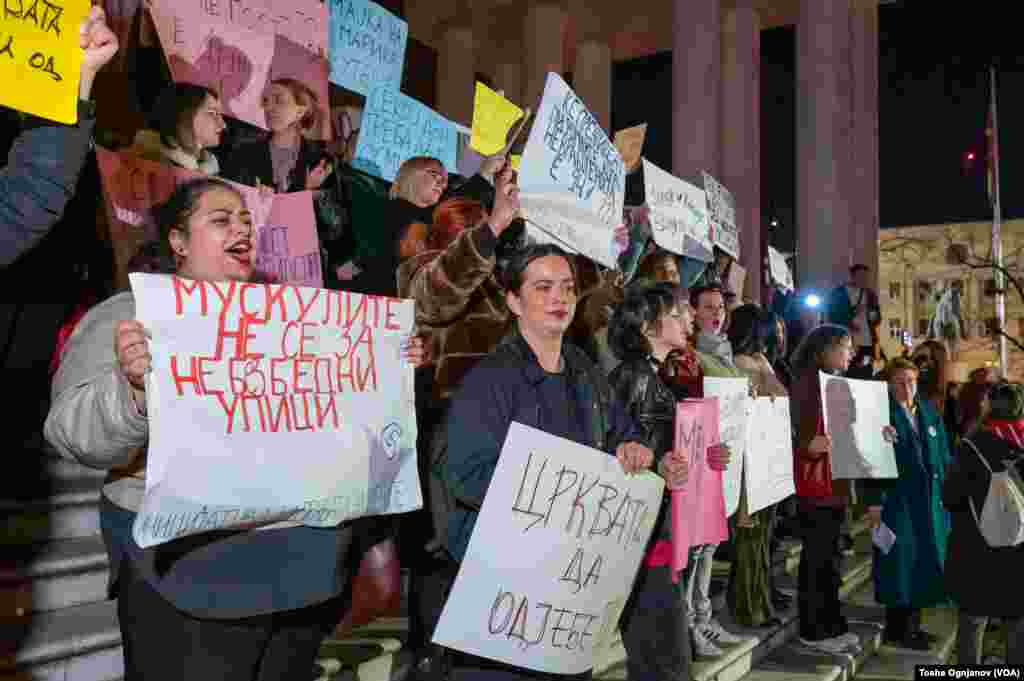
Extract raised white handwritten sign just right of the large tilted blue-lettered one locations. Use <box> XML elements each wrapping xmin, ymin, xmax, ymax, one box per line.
<box><xmin>643</xmin><ymin>159</ymin><xmax>712</xmax><ymax>255</ymax></box>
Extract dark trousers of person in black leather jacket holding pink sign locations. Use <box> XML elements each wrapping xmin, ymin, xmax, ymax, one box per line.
<box><xmin>620</xmin><ymin>566</ymin><xmax>690</xmax><ymax>681</ymax></box>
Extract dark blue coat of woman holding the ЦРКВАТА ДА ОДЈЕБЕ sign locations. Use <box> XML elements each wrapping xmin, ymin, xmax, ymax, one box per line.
<box><xmin>443</xmin><ymin>331</ymin><xmax>647</xmax><ymax>561</ymax></box>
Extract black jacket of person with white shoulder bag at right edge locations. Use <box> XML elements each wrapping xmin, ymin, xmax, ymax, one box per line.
<box><xmin>942</xmin><ymin>430</ymin><xmax>1024</xmax><ymax>618</ymax></box>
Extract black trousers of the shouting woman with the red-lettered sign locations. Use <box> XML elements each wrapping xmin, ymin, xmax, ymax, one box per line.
<box><xmin>118</xmin><ymin>560</ymin><xmax>346</xmax><ymax>681</ymax></box>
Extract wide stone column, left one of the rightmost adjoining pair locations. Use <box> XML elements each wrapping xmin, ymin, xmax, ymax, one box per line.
<box><xmin>797</xmin><ymin>0</ymin><xmax>853</xmax><ymax>291</ymax></box>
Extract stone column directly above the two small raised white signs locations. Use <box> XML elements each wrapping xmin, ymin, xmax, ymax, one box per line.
<box><xmin>671</xmin><ymin>0</ymin><xmax>731</xmax><ymax>178</ymax></box>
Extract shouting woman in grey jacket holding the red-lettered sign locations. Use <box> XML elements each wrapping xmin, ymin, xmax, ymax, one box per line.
<box><xmin>45</xmin><ymin>178</ymin><xmax>423</xmax><ymax>681</ymax></box>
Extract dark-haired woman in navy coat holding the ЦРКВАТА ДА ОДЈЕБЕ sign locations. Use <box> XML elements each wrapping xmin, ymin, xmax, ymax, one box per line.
<box><xmin>443</xmin><ymin>245</ymin><xmax>653</xmax><ymax>680</ymax></box>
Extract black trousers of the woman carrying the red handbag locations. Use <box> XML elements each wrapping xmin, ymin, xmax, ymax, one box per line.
<box><xmin>797</xmin><ymin>505</ymin><xmax>849</xmax><ymax>641</ymax></box>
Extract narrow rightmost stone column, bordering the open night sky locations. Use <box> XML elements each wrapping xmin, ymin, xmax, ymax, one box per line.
<box><xmin>850</xmin><ymin>0</ymin><xmax>880</xmax><ymax>287</ymax></box>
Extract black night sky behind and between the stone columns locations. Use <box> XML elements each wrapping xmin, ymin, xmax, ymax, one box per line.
<box><xmin>612</xmin><ymin>0</ymin><xmax>1024</xmax><ymax>258</ymax></box>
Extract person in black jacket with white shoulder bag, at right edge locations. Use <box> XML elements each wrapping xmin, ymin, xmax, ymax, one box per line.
<box><xmin>942</xmin><ymin>383</ymin><xmax>1024</xmax><ymax>665</ymax></box>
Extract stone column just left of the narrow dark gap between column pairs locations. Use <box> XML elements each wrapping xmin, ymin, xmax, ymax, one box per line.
<box><xmin>721</xmin><ymin>3</ymin><xmax>765</xmax><ymax>302</ymax></box>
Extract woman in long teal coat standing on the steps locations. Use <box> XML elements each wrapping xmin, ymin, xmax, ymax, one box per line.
<box><xmin>863</xmin><ymin>358</ymin><xmax>949</xmax><ymax>650</ymax></box>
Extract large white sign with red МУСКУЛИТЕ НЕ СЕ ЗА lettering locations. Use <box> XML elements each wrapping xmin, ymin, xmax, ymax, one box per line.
<box><xmin>130</xmin><ymin>273</ymin><xmax>422</xmax><ymax>548</ymax></box>
